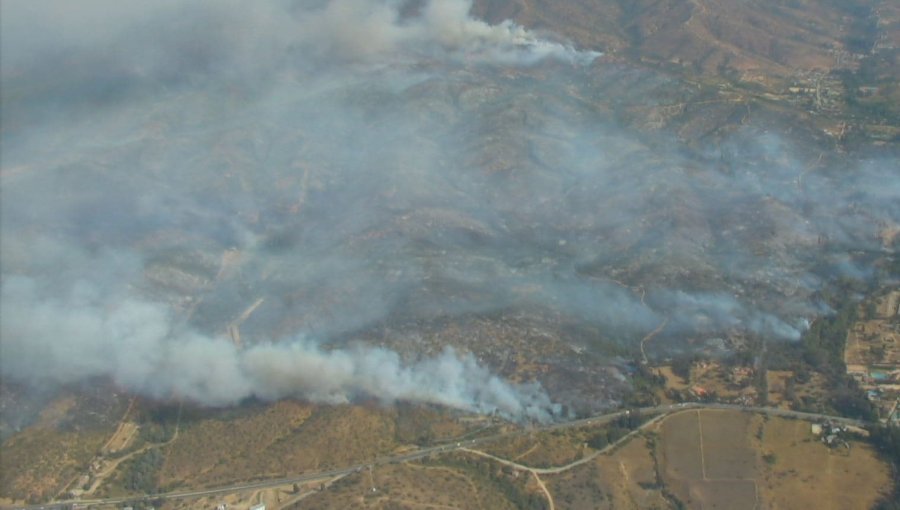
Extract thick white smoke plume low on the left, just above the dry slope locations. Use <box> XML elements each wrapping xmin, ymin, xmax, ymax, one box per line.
<box><xmin>0</xmin><ymin>276</ymin><xmax>554</xmax><ymax>421</ymax></box>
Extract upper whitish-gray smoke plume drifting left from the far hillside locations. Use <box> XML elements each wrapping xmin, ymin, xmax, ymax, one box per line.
<box><xmin>0</xmin><ymin>0</ymin><xmax>600</xmax><ymax>79</ymax></box>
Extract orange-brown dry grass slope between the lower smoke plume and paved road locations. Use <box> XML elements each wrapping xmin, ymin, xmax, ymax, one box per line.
<box><xmin>89</xmin><ymin>401</ymin><xmax>485</xmax><ymax>494</ymax></box>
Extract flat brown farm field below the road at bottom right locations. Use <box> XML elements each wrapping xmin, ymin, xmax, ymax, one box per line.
<box><xmin>656</xmin><ymin>410</ymin><xmax>890</xmax><ymax>510</ymax></box>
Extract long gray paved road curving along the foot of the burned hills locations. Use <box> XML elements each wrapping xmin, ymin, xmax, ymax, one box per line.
<box><xmin>0</xmin><ymin>402</ymin><xmax>866</xmax><ymax>510</ymax></box>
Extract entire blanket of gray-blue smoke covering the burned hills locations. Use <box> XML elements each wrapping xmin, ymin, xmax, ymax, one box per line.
<box><xmin>0</xmin><ymin>0</ymin><xmax>900</xmax><ymax>419</ymax></box>
